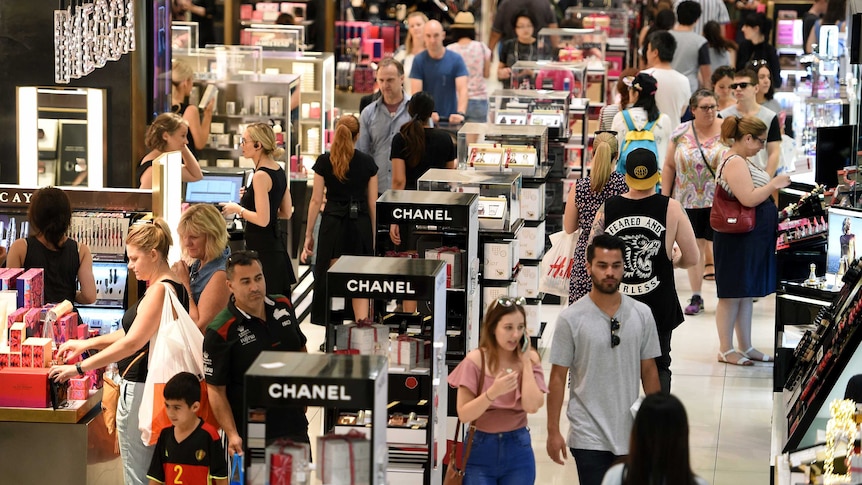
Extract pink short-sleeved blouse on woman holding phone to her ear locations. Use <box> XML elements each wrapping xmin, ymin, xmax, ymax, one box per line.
<box><xmin>448</xmin><ymin>359</ymin><xmax>548</xmax><ymax>433</ymax></box>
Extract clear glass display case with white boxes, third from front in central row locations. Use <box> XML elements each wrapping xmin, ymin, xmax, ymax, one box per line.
<box><xmin>490</xmin><ymin>89</ymin><xmax>572</xmax><ymax>140</ymax></box>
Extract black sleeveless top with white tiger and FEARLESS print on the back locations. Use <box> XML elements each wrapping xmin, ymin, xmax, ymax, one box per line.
<box><xmin>605</xmin><ymin>194</ymin><xmax>684</xmax><ymax>333</ymax></box>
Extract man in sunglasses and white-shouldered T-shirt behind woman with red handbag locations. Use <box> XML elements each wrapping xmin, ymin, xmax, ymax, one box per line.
<box><xmin>721</xmin><ymin>69</ymin><xmax>781</xmax><ymax>176</ymax></box>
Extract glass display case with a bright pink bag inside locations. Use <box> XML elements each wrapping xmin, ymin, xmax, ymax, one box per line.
<box><xmin>510</xmin><ymin>61</ymin><xmax>587</xmax><ymax>98</ymax></box>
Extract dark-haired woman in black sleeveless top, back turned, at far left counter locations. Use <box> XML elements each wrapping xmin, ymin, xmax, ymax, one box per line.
<box><xmin>6</xmin><ymin>187</ymin><xmax>96</xmax><ymax>305</ymax></box>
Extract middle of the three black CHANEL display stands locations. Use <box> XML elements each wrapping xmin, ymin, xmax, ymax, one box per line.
<box><xmin>325</xmin><ymin>256</ymin><xmax>448</xmax><ymax>485</ymax></box>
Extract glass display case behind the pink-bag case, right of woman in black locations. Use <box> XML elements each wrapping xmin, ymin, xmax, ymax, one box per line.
<box><xmin>536</xmin><ymin>27</ymin><xmax>608</xmax><ymax>65</ymax></box>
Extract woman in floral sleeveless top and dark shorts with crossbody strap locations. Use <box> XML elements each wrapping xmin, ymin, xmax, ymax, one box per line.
<box><xmin>661</xmin><ymin>89</ymin><xmax>727</xmax><ymax>315</ymax></box>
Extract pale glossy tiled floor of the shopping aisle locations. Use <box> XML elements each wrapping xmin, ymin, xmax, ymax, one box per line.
<box><xmin>302</xmin><ymin>264</ymin><xmax>775</xmax><ymax>485</ymax></box>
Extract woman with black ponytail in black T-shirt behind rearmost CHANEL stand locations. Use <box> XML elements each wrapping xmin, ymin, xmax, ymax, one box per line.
<box><xmin>389</xmin><ymin>91</ymin><xmax>457</xmax><ymax>249</ymax></box>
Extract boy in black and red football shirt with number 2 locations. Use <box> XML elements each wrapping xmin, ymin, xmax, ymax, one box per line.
<box><xmin>147</xmin><ymin>372</ymin><xmax>228</xmax><ymax>485</ymax></box>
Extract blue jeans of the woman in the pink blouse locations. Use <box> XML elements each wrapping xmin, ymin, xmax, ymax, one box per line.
<box><xmin>464</xmin><ymin>428</ymin><xmax>536</xmax><ymax>485</ymax></box>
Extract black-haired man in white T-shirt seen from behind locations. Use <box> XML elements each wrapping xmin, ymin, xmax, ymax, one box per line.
<box><xmin>643</xmin><ymin>31</ymin><xmax>691</xmax><ymax>130</ymax></box>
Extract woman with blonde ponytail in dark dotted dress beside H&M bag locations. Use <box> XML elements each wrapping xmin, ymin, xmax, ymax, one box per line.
<box><xmin>563</xmin><ymin>131</ymin><xmax>629</xmax><ymax>305</ymax></box>
